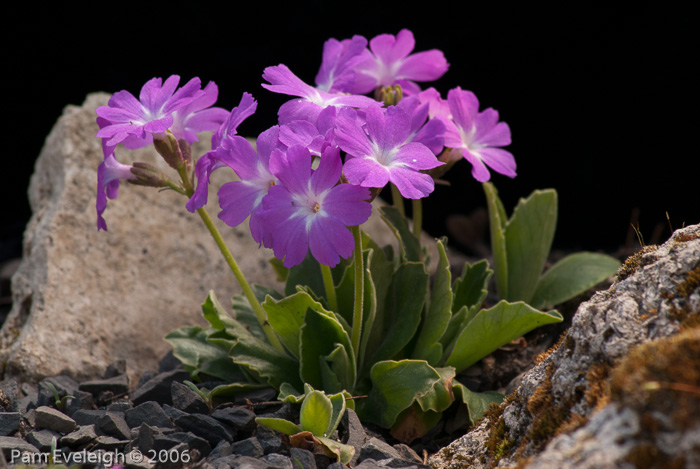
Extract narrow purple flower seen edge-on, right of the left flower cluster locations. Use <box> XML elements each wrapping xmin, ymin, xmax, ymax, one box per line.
<box><xmin>186</xmin><ymin>93</ymin><xmax>258</xmax><ymax>212</ymax></box>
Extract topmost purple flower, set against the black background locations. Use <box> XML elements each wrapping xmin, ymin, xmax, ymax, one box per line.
<box><xmin>353</xmin><ymin>29</ymin><xmax>449</xmax><ymax>95</ymax></box>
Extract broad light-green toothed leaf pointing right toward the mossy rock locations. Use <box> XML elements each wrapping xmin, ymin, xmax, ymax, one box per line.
<box><xmin>445</xmin><ymin>301</ymin><xmax>563</xmax><ymax>373</ymax></box>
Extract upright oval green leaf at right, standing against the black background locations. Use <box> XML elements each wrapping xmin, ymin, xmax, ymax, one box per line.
<box><xmin>501</xmin><ymin>189</ymin><xmax>557</xmax><ymax>303</ymax></box>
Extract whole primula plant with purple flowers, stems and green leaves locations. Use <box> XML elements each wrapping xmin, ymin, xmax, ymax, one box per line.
<box><xmin>97</xmin><ymin>30</ymin><xmax>618</xmax><ymax>444</ymax></box>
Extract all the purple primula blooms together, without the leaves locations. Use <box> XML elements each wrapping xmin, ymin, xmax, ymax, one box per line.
<box><xmin>97</xmin><ymin>30</ymin><xmax>515</xmax><ymax>267</ymax></box>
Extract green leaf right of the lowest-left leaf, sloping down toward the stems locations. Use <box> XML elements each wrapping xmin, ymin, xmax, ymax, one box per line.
<box><xmin>209</xmin><ymin>328</ymin><xmax>302</xmax><ymax>389</ymax></box>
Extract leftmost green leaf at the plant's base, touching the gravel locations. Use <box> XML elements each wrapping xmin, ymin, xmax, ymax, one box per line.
<box><xmin>165</xmin><ymin>326</ymin><xmax>246</xmax><ymax>382</ymax></box>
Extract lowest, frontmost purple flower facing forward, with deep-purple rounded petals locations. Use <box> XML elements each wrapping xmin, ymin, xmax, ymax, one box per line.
<box><xmin>260</xmin><ymin>145</ymin><xmax>372</xmax><ymax>267</ymax></box>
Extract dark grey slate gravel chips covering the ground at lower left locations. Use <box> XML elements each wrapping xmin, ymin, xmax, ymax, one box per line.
<box><xmin>0</xmin><ymin>360</ymin><xmax>429</xmax><ymax>469</ymax></box>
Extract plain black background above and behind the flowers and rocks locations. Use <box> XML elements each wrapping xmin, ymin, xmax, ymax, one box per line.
<box><xmin>0</xmin><ymin>1</ymin><xmax>700</xmax><ymax>260</ymax></box>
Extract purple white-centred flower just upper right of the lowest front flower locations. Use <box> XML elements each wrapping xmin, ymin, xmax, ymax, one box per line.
<box><xmin>335</xmin><ymin>106</ymin><xmax>443</xmax><ymax>199</ymax></box>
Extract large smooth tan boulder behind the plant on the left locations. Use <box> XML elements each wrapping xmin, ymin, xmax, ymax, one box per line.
<box><xmin>0</xmin><ymin>93</ymin><xmax>454</xmax><ymax>382</ymax></box>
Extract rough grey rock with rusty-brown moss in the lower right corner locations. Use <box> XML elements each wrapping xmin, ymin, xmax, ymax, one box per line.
<box><xmin>430</xmin><ymin>225</ymin><xmax>700</xmax><ymax>469</ymax></box>
